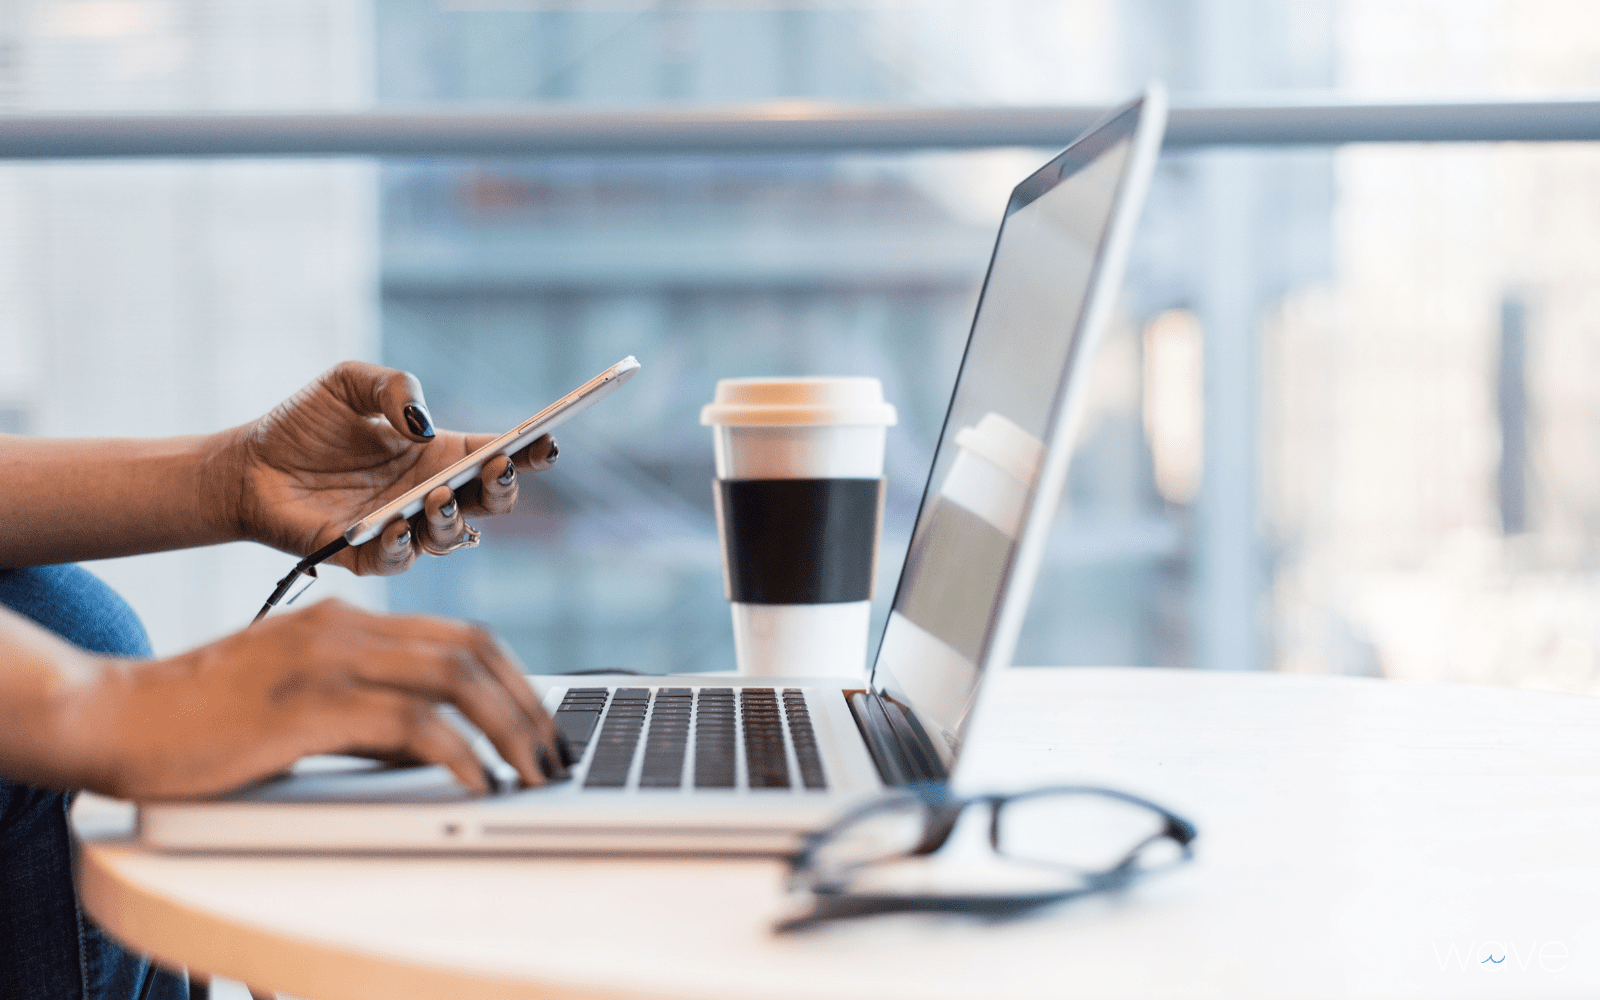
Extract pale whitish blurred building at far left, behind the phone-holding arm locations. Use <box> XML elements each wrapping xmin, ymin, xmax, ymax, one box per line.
<box><xmin>0</xmin><ymin>0</ymin><xmax>384</xmax><ymax>653</ymax></box>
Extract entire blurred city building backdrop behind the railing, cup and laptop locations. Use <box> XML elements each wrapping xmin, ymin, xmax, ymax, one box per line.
<box><xmin>0</xmin><ymin>0</ymin><xmax>1600</xmax><ymax>690</ymax></box>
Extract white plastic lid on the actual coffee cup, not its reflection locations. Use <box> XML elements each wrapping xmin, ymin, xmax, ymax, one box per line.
<box><xmin>701</xmin><ymin>376</ymin><xmax>896</xmax><ymax>427</ymax></box>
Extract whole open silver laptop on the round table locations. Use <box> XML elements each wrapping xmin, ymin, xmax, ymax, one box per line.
<box><xmin>139</xmin><ymin>85</ymin><xmax>1166</xmax><ymax>854</ymax></box>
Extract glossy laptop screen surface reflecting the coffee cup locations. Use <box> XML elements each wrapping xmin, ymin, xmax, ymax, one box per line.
<box><xmin>872</xmin><ymin>110</ymin><xmax>1138</xmax><ymax>765</ymax></box>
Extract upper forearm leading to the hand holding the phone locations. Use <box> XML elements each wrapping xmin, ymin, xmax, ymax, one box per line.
<box><xmin>0</xmin><ymin>430</ymin><xmax>243</xmax><ymax>566</ymax></box>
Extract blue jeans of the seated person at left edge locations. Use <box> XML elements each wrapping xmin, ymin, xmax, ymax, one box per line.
<box><xmin>0</xmin><ymin>566</ymin><xmax>189</xmax><ymax>1000</ymax></box>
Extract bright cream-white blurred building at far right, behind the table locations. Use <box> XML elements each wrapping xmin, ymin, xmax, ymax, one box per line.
<box><xmin>1262</xmin><ymin>0</ymin><xmax>1600</xmax><ymax>691</ymax></box>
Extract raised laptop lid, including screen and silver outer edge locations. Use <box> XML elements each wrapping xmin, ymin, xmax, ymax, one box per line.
<box><xmin>872</xmin><ymin>85</ymin><xmax>1166</xmax><ymax>770</ymax></box>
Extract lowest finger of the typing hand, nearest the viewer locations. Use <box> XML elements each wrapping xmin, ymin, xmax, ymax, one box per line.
<box><xmin>325</xmin><ymin>686</ymin><xmax>491</xmax><ymax>795</ymax></box>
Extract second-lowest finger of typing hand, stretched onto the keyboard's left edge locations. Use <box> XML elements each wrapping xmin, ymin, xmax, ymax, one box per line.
<box><xmin>354</xmin><ymin>637</ymin><xmax>558</xmax><ymax>787</ymax></box>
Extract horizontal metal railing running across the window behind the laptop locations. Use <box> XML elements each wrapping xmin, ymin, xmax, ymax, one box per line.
<box><xmin>0</xmin><ymin>99</ymin><xmax>1600</xmax><ymax>158</ymax></box>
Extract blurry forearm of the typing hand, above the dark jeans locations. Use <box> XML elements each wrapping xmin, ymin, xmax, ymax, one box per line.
<box><xmin>0</xmin><ymin>606</ymin><xmax>107</xmax><ymax>789</ymax></box>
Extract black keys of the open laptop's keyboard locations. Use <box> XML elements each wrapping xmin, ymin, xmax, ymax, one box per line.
<box><xmin>555</xmin><ymin>688</ymin><xmax>827</xmax><ymax>790</ymax></box>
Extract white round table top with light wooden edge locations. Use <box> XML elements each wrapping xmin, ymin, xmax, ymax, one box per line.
<box><xmin>77</xmin><ymin>669</ymin><xmax>1600</xmax><ymax>1000</ymax></box>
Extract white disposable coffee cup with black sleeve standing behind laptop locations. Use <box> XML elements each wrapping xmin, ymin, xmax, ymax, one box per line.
<box><xmin>701</xmin><ymin>378</ymin><xmax>896</xmax><ymax>677</ymax></box>
